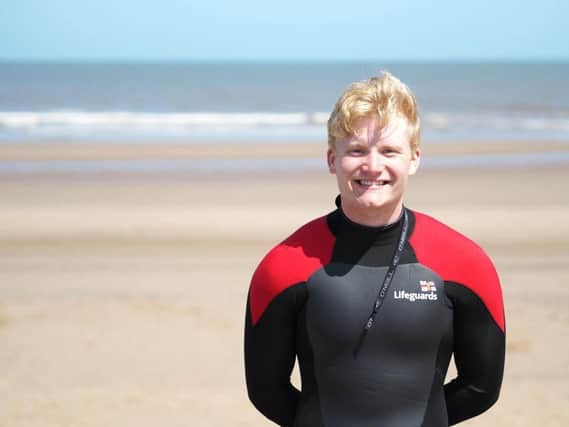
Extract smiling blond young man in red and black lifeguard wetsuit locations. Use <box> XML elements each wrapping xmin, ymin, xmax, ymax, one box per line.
<box><xmin>245</xmin><ymin>73</ymin><xmax>505</xmax><ymax>427</ymax></box>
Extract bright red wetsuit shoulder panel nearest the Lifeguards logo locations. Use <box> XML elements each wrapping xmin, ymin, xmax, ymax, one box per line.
<box><xmin>409</xmin><ymin>212</ymin><xmax>505</xmax><ymax>332</ymax></box>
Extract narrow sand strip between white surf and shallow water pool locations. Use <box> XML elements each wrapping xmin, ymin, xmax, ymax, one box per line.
<box><xmin>0</xmin><ymin>139</ymin><xmax>569</xmax><ymax>161</ymax></box>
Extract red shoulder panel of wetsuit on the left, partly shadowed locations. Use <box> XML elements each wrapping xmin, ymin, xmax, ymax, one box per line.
<box><xmin>249</xmin><ymin>217</ymin><xmax>335</xmax><ymax>325</ymax></box>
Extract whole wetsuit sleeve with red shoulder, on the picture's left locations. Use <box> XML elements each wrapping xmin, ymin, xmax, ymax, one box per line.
<box><xmin>245</xmin><ymin>217</ymin><xmax>334</xmax><ymax>426</ymax></box>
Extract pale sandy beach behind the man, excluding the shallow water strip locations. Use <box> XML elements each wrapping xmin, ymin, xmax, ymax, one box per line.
<box><xmin>0</xmin><ymin>141</ymin><xmax>569</xmax><ymax>427</ymax></box>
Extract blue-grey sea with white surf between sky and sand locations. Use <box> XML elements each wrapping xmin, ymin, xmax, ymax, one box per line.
<box><xmin>0</xmin><ymin>63</ymin><xmax>569</xmax><ymax>143</ymax></box>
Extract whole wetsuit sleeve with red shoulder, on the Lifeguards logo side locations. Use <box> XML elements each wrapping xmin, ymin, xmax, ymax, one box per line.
<box><xmin>410</xmin><ymin>212</ymin><xmax>505</xmax><ymax>425</ymax></box>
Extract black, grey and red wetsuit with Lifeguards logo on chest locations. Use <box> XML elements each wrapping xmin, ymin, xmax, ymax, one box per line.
<box><xmin>245</xmin><ymin>203</ymin><xmax>505</xmax><ymax>427</ymax></box>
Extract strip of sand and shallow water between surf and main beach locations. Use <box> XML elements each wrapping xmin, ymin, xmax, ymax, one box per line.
<box><xmin>0</xmin><ymin>141</ymin><xmax>569</xmax><ymax>176</ymax></box>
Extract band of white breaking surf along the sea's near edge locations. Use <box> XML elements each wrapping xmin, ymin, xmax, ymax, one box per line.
<box><xmin>0</xmin><ymin>111</ymin><xmax>569</xmax><ymax>139</ymax></box>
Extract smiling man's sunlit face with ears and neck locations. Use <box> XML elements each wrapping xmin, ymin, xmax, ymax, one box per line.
<box><xmin>328</xmin><ymin>117</ymin><xmax>420</xmax><ymax>225</ymax></box>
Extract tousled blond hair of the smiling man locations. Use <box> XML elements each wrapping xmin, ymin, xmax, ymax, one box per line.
<box><xmin>328</xmin><ymin>71</ymin><xmax>421</xmax><ymax>150</ymax></box>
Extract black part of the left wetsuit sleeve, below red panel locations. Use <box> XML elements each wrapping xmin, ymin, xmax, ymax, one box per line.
<box><xmin>245</xmin><ymin>288</ymin><xmax>300</xmax><ymax>426</ymax></box>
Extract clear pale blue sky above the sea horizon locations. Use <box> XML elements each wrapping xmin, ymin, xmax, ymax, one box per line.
<box><xmin>0</xmin><ymin>0</ymin><xmax>569</xmax><ymax>61</ymax></box>
